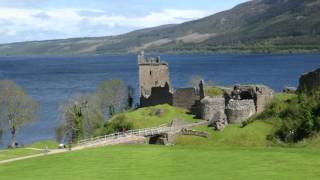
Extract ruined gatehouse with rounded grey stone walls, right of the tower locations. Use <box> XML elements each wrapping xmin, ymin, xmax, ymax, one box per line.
<box><xmin>201</xmin><ymin>85</ymin><xmax>274</xmax><ymax>129</ymax></box>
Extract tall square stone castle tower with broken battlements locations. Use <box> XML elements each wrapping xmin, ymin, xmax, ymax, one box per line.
<box><xmin>138</xmin><ymin>52</ymin><xmax>173</xmax><ymax>107</ymax></box>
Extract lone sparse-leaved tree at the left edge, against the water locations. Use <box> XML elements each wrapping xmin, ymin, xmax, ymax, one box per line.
<box><xmin>0</xmin><ymin>80</ymin><xmax>37</xmax><ymax>148</ymax></box>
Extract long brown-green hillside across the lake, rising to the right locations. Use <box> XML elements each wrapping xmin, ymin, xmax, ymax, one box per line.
<box><xmin>0</xmin><ymin>0</ymin><xmax>320</xmax><ymax>56</ymax></box>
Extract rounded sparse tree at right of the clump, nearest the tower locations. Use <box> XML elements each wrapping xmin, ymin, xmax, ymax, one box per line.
<box><xmin>97</xmin><ymin>80</ymin><xmax>128</xmax><ymax>116</ymax></box>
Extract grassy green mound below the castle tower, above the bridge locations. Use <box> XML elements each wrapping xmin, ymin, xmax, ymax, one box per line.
<box><xmin>111</xmin><ymin>105</ymin><xmax>197</xmax><ymax>129</ymax></box>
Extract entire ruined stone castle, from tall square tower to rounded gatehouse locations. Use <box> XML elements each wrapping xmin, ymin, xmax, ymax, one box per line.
<box><xmin>138</xmin><ymin>52</ymin><xmax>274</xmax><ymax>129</ymax></box>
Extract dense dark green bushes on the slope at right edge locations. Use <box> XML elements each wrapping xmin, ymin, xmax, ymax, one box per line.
<box><xmin>242</xmin><ymin>92</ymin><xmax>320</xmax><ymax>143</ymax></box>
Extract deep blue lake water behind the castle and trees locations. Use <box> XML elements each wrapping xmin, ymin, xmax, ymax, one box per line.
<box><xmin>0</xmin><ymin>55</ymin><xmax>320</xmax><ymax>145</ymax></box>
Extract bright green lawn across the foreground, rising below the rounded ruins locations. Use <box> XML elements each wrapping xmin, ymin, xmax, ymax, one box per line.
<box><xmin>0</xmin><ymin>122</ymin><xmax>320</xmax><ymax>180</ymax></box>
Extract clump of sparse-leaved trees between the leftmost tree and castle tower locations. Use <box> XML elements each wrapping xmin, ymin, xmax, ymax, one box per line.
<box><xmin>56</xmin><ymin>80</ymin><xmax>134</xmax><ymax>143</ymax></box>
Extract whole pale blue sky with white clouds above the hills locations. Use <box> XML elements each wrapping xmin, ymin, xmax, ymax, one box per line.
<box><xmin>0</xmin><ymin>0</ymin><xmax>248</xmax><ymax>43</ymax></box>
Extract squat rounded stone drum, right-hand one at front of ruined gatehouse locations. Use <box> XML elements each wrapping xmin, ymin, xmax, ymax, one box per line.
<box><xmin>226</xmin><ymin>99</ymin><xmax>256</xmax><ymax>124</ymax></box>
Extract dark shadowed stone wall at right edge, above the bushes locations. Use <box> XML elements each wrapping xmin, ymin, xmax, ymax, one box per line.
<box><xmin>298</xmin><ymin>68</ymin><xmax>320</xmax><ymax>93</ymax></box>
